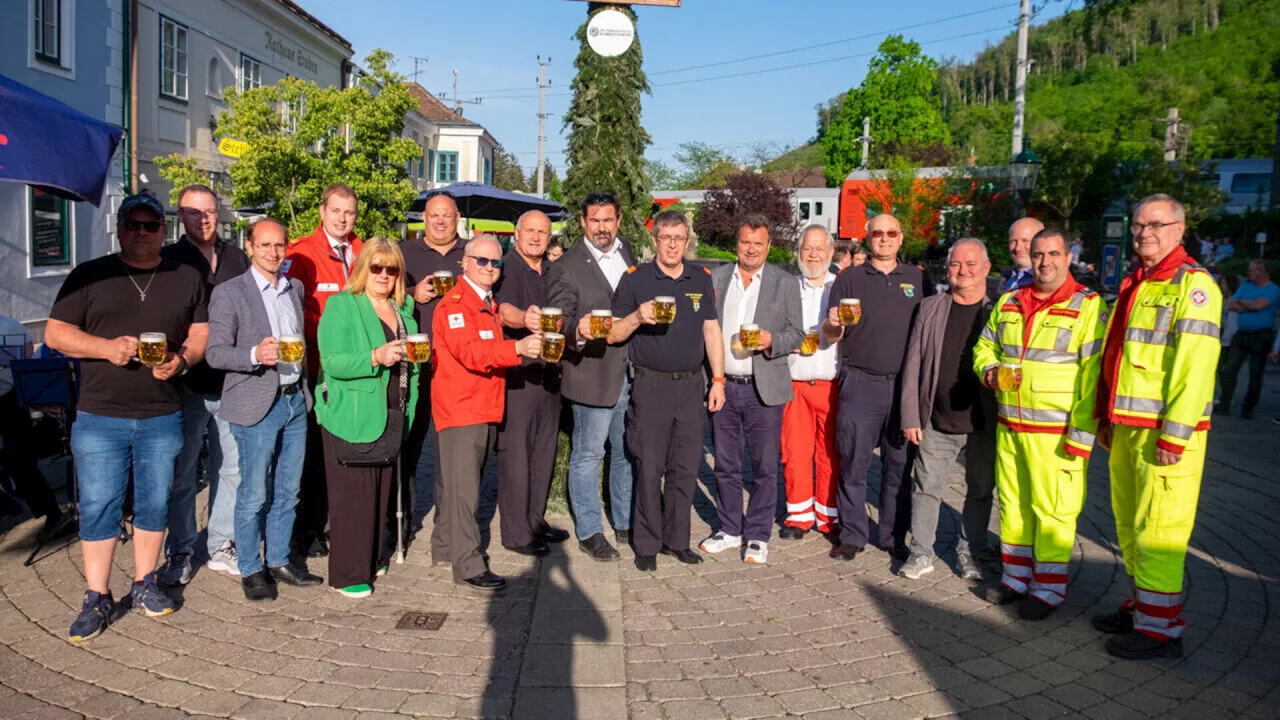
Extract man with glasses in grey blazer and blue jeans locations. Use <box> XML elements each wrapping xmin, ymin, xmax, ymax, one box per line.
<box><xmin>205</xmin><ymin>220</ymin><xmax>323</xmax><ymax>601</ymax></box>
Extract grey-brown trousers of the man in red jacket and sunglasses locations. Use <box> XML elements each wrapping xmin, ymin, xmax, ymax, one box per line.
<box><xmin>431</xmin><ymin>424</ymin><xmax>488</xmax><ymax>580</ymax></box>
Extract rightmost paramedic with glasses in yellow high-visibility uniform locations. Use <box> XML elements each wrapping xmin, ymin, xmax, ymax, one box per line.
<box><xmin>1093</xmin><ymin>195</ymin><xmax>1222</xmax><ymax>660</ymax></box>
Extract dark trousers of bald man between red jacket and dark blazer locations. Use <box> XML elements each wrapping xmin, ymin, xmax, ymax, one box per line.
<box><xmin>498</xmin><ymin>369</ymin><xmax>559</xmax><ymax>547</ymax></box>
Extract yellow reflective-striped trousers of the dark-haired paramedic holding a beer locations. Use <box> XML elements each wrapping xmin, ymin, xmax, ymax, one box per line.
<box><xmin>996</xmin><ymin>425</ymin><xmax>1085</xmax><ymax>606</ymax></box>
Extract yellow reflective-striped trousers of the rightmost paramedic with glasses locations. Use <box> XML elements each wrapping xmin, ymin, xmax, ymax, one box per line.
<box><xmin>1111</xmin><ymin>425</ymin><xmax>1207</xmax><ymax>638</ymax></box>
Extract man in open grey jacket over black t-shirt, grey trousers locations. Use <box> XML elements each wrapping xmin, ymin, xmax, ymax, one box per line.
<box><xmin>897</xmin><ymin>238</ymin><xmax>996</xmax><ymax>580</ymax></box>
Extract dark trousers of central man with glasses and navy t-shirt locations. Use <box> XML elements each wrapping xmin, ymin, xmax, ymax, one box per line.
<box><xmin>627</xmin><ymin>369</ymin><xmax>707</xmax><ymax>555</ymax></box>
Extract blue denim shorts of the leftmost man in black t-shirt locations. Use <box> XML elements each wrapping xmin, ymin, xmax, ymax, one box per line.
<box><xmin>72</xmin><ymin>410</ymin><xmax>182</xmax><ymax>542</ymax></box>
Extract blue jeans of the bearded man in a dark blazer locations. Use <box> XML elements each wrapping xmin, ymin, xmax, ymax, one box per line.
<box><xmin>568</xmin><ymin>379</ymin><xmax>635</xmax><ymax>541</ymax></box>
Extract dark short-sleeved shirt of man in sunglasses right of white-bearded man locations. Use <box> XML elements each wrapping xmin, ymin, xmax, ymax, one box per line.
<box><xmin>827</xmin><ymin>261</ymin><xmax>928</xmax><ymax>375</ymax></box>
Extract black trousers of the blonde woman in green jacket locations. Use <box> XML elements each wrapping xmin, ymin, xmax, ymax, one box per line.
<box><xmin>322</xmin><ymin>429</ymin><xmax>396</xmax><ymax>588</ymax></box>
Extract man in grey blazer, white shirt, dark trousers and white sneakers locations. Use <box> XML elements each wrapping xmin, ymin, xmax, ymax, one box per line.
<box><xmin>700</xmin><ymin>215</ymin><xmax>804</xmax><ymax>565</ymax></box>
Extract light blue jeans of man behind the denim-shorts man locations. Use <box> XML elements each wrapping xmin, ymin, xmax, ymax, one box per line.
<box><xmin>165</xmin><ymin>395</ymin><xmax>239</xmax><ymax>555</ymax></box>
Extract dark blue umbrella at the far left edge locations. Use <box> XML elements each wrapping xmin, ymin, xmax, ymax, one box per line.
<box><xmin>0</xmin><ymin>76</ymin><xmax>124</xmax><ymax>205</ymax></box>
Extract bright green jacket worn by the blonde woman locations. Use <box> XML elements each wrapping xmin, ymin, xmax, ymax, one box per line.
<box><xmin>315</xmin><ymin>291</ymin><xmax>419</xmax><ymax>442</ymax></box>
